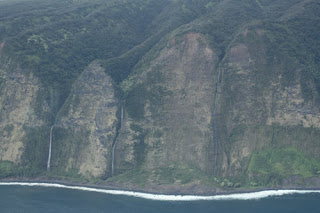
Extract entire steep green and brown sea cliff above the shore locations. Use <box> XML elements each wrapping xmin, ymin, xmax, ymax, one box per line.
<box><xmin>0</xmin><ymin>0</ymin><xmax>320</xmax><ymax>193</ymax></box>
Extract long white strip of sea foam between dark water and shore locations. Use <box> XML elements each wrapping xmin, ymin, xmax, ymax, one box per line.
<box><xmin>0</xmin><ymin>182</ymin><xmax>320</xmax><ymax>201</ymax></box>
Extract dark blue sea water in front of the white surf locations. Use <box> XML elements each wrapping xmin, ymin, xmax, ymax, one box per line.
<box><xmin>0</xmin><ymin>186</ymin><xmax>320</xmax><ymax>213</ymax></box>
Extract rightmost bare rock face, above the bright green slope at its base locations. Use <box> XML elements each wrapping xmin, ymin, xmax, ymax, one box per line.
<box><xmin>220</xmin><ymin>29</ymin><xmax>320</xmax><ymax>176</ymax></box>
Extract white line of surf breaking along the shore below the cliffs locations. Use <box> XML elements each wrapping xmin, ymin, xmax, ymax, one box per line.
<box><xmin>0</xmin><ymin>180</ymin><xmax>320</xmax><ymax>201</ymax></box>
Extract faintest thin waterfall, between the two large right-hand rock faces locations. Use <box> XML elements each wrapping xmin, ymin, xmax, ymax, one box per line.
<box><xmin>213</xmin><ymin>62</ymin><xmax>221</xmax><ymax>173</ymax></box>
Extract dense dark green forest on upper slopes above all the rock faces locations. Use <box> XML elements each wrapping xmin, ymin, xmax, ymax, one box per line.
<box><xmin>0</xmin><ymin>0</ymin><xmax>320</xmax><ymax>113</ymax></box>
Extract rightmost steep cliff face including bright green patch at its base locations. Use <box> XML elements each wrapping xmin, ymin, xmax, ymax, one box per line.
<box><xmin>219</xmin><ymin>26</ymin><xmax>320</xmax><ymax>183</ymax></box>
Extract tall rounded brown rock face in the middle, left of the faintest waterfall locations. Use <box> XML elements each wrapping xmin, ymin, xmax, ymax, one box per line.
<box><xmin>145</xmin><ymin>33</ymin><xmax>217</xmax><ymax>171</ymax></box>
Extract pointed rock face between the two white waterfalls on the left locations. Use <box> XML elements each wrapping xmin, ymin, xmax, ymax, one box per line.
<box><xmin>52</xmin><ymin>62</ymin><xmax>119</xmax><ymax>177</ymax></box>
